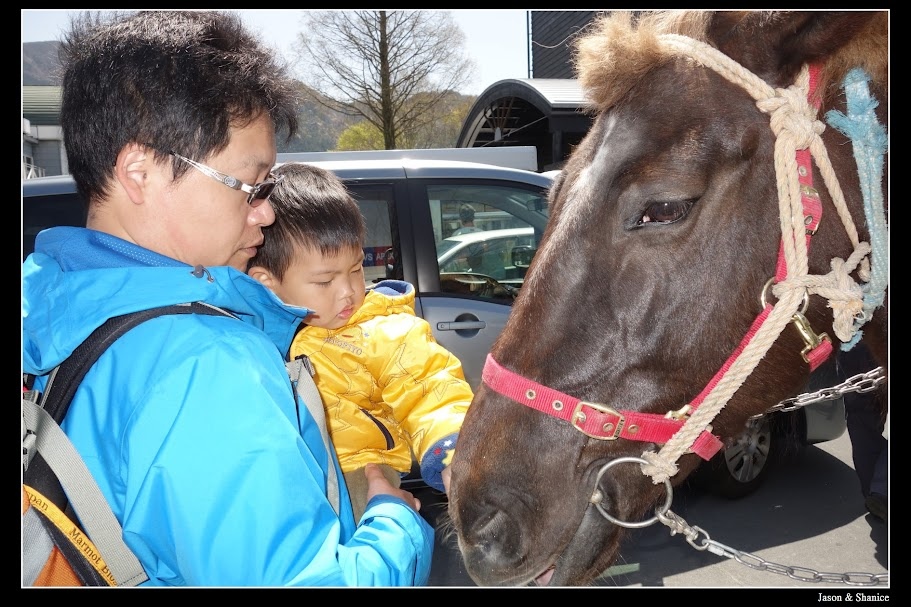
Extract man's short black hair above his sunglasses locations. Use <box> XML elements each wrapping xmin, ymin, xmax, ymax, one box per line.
<box><xmin>60</xmin><ymin>10</ymin><xmax>299</xmax><ymax>207</ymax></box>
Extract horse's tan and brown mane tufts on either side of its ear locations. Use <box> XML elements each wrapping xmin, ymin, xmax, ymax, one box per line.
<box><xmin>572</xmin><ymin>10</ymin><xmax>889</xmax><ymax>112</ymax></box>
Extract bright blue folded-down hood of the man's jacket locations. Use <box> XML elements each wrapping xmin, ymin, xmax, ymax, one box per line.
<box><xmin>22</xmin><ymin>227</ymin><xmax>310</xmax><ymax>375</ymax></box>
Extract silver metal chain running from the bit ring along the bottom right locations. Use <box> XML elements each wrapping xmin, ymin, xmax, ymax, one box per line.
<box><xmin>655</xmin><ymin>509</ymin><xmax>889</xmax><ymax>586</ymax></box>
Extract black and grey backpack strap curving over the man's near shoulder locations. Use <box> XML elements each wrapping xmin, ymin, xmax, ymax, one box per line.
<box><xmin>22</xmin><ymin>302</ymin><xmax>232</xmax><ymax>586</ymax></box>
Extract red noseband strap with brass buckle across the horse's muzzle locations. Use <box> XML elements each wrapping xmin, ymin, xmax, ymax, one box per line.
<box><xmin>482</xmin><ymin>354</ymin><xmax>722</xmax><ymax>460</ymax></box>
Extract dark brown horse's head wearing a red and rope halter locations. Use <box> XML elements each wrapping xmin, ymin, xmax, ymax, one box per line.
<box><xmin>449</xmin><ymin>11</ymin><xmax>889</xmax><ymax>585</ymax></box>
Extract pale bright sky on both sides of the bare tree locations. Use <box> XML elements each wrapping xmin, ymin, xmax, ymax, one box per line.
<box><xmin>21</xmin><ymin>9</ymin><xmax>528</xmax><ymax>95</ymax></box>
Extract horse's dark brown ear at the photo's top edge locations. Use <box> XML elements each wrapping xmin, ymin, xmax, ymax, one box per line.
<box><xmin>709</xmin><ymin>11</ymin><xmax>877</xmax><ymax>87</ymax></box>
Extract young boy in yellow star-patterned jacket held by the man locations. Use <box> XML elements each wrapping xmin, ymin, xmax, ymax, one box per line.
<box><xmin>247</xmin><ymin>164</ymin><xmax>472</xmax><ymax>520</ymax></box>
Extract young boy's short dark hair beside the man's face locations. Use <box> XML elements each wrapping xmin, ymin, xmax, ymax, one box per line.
<box><xmin>247</xmin><ymin>162</ymin><xmax>367</xmax><ymax>280</ymax></box>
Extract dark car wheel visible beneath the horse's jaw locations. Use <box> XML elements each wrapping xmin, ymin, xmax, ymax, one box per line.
<box><xmin>693</xmin><ymin>416</ymin><xmax>784</xmax><ymax>499</ymax></box>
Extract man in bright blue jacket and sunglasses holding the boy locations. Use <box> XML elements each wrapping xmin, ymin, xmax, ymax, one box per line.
<box><xmin>22</xmin><ymin>11</ymin><xmax>433</xmax><ymax>586</ymax></box>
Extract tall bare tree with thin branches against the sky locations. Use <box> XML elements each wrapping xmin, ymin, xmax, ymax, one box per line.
<box><xmin>297</xmin><ymin>10</ymin><xmax>474</xmax><ymax>149</ymax></box>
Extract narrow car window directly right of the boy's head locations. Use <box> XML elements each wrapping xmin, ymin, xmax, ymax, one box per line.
<box><xmin>347</xmin><ymin>183</ymin><xmax>403</xmax><ymax>285</ymax></box>
